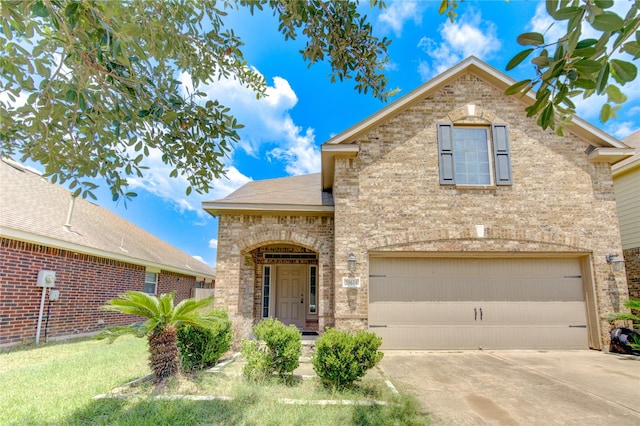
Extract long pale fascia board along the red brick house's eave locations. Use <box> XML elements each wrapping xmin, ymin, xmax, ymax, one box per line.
<box><xmin>0</xmin><ymin>226</ymin><xmax>215</xmax><ymax>278</ymax></box>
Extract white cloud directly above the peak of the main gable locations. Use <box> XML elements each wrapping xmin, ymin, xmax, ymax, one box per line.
<box><xmin>418</xmin><ymin>8</ymin><xmax>501</xmax><ymax>80</ymax></box>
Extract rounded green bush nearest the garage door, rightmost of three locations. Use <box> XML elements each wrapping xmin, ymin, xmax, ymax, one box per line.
<box><xmin>311</xmin><ymin>329</ymin><xmax>383</xmax><ymax>388</ymax></box>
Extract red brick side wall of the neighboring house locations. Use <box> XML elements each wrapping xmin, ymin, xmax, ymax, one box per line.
<box><xmin>0</xmin><ymin>238</ymin><xmax>195</xmax><ymax>346</ymax></box>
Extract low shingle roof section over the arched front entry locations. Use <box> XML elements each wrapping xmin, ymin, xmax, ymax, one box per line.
<box><xmin>202</xmin><ymin>173</ymin><xmax>333</xmax><ymax>216</ymax></box>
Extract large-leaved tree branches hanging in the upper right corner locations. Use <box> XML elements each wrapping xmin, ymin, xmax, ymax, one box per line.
<box><xmin>440</xmin><ymin>0</ymin><xmax>640</xmax><ymax>135</ymax></box>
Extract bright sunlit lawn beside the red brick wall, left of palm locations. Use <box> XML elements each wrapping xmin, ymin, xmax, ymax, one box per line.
<box><xmin>0</xmin><ymin>336</ymin><xmax>150</xmax><ymax>425</ymax></box>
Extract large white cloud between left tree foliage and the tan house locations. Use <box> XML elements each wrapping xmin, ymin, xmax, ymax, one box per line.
<box><xmin>129</xmin><ymin>68</ymin><xmax>320</xmax><ymax>218</ymax></box>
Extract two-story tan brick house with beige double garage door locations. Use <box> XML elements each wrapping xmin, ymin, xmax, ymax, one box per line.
<box><xmin>203</xmin><ymin>57</ymin><xmax>632</xmax><ymax>349</ymax></box>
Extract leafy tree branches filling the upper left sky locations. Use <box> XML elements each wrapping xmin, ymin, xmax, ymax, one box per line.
<box><xmin>0</xmin><ymin>0</ymin><xmax>389</xmax><ymax>199</ymax></box>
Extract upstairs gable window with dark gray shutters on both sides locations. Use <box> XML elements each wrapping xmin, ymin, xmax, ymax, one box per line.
<box><xmin>438</xmin><ymin>124</ymin><xmax>512</xmax><ymax>186</ymax></box>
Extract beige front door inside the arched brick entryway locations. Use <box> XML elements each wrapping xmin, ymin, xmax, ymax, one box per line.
<box><xmin>276</xmin><ymin>265</ymin><xmax>307</xmax><ymax>329</ymax></box>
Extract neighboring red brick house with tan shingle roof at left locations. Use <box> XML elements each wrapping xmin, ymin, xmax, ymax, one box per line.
<box><xmin>0</xmin><ymin>160</ymin><xmax>215</xmax><ymax>346</ymax></box>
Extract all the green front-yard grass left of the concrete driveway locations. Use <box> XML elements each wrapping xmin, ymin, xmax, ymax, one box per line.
<box><xmin>0</xmin><ymin>336</ymin><xmax>429</xmax><ymax>426</ymax></box>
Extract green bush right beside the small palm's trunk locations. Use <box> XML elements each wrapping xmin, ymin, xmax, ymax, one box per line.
<box><xmin>178</xmin><ymin>309</ymin><xmax>233</xmax><ymax>371</ymax></box>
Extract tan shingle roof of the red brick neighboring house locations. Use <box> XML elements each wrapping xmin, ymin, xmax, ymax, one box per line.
<box><xmin>0</xmin><ymin>159</ymin><xmax>215</xmax><ymax>279</ymax></box>
